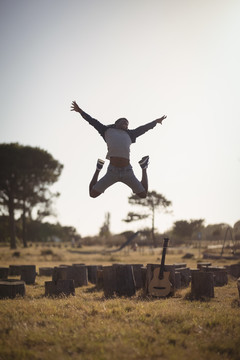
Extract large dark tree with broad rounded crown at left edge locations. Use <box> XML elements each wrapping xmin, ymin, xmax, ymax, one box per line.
<box><xmin>0</xmin><ymin>143</ymin><xmax>63</xmax><ymax>249</ymax></box>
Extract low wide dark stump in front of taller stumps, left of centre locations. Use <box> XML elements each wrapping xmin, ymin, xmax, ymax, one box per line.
<box><xmin>45</xmin><ymin>279</ymin><xmax>75</xmax><ymax>296</ymax></box>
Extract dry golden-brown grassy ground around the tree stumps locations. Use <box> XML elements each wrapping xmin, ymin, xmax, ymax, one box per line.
<box><xmin>0</xmin><ymin>247</ymin><xmax>240</xmax><ymax>360</ymax></box>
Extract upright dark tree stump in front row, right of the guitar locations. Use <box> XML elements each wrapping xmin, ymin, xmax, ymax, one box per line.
<box><xmin>191</xmin><ymin>270</ymin><xmax>214</xmax><ymax>299</ymax></box>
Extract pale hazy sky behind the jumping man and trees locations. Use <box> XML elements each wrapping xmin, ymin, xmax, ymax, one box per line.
<box><xmin>0</xmin><ymin>0</ymin><xmax>240</xmax><ymax>236</ymax></box>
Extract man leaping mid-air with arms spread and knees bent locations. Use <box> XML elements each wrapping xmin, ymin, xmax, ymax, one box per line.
<box><xmin>71</xmin><ymin>101</ymin><xmax>166</xmax><ymax>198</ymax></box>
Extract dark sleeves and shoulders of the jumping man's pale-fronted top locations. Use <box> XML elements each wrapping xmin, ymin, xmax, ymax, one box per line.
<box><xmin>81</xmin><ymin>110</ymin><xmax>157</xmax><ymax>143</ymax></box>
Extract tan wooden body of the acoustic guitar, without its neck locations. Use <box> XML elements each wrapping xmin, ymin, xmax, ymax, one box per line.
<box><xmin>148</xmin><ymin>267</ymin><xmax>172</xmax><ymax>297</ymax></box>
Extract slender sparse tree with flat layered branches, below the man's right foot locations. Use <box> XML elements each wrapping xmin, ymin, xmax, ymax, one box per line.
<box><xmin>124</xmin><ymin>190</ymin><xmax>172</xmax><ymax>247</ymax></box>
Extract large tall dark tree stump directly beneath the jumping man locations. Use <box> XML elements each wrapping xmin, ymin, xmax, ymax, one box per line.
<box><xmin>113</xmin><ymin>264</ymin><xmax>136</xmax><ymax>297</ymax></box>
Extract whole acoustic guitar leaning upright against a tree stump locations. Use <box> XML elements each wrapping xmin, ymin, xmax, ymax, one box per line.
<box><xmin>148</xmin><ymin>238</ymin><xmax>172</xmax><ymax>297</ymax></box>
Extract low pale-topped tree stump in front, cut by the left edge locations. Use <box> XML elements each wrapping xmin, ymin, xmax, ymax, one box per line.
<box><xmin>0</xmin><ymin>279</ymin><xmax>26</xmax><ymax>299</ymax></box>
